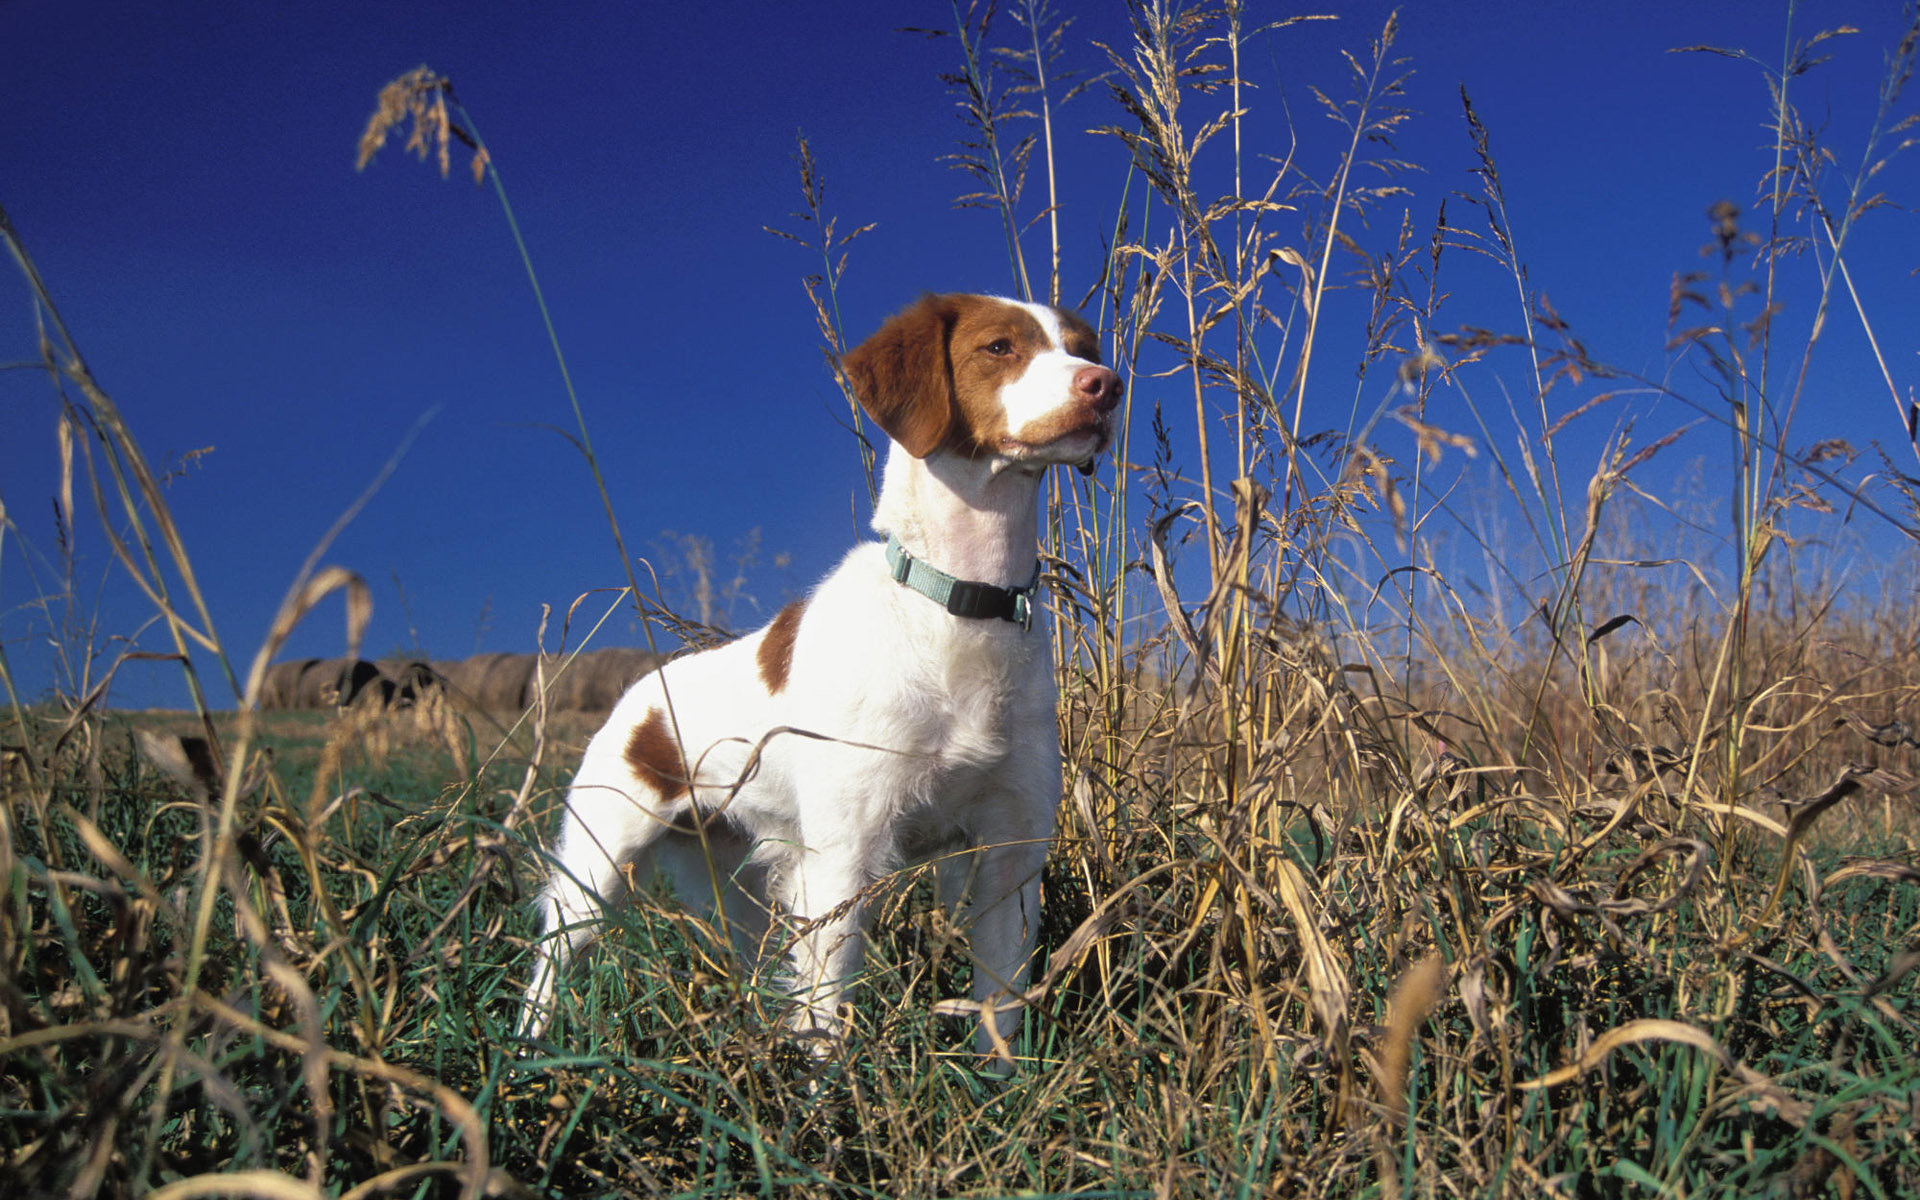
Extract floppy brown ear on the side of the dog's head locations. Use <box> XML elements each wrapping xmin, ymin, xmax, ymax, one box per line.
<box><xmin>841</xmin><ymin>296</ymin><xmax>958</xmax><ymax>459</ymax></box>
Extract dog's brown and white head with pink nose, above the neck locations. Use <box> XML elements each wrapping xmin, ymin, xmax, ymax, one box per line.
<box><xmin>845</xmin><ymin>296</ymin><xmax>1119</xmax><ymax>472</ymax></box>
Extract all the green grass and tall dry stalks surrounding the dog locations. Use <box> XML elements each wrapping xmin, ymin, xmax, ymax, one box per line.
<box><xmin>0</xmin><ymin>2</ymin><xmax>1920</xmax><ymax>1198</ymax></box>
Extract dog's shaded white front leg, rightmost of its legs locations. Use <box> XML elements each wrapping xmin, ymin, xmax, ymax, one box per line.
<box><xmin>972</xmin><ymin>833</ymin><xmax>1046</xmax><ymax>1075</ymax></box>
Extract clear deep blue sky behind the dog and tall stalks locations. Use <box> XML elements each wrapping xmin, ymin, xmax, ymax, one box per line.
<box><xmin>0</xmin><ymin>0</ymin><xmax>1920</xmax><ymax>707</ymax></box>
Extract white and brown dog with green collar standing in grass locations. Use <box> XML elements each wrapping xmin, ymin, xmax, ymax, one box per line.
<box><xmin>518</xmin><ymin>294</ymin><xmax>1121</xmax><ymax>1073</ymax></box>
